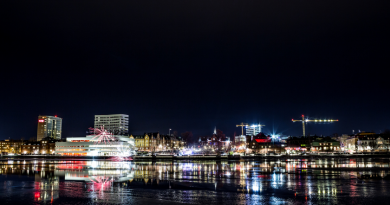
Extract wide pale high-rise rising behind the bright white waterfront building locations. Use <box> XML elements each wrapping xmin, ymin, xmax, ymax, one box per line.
<box><xmin>94</xmin><ymin>114</ymin><xmax>129</xmax><ymax>135</ymax></box>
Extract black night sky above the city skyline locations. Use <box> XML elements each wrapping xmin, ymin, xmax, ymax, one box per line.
<box><xmin>0</xmin><ymin>0</ymin><xmax>390</xmax><ymax>139</ymax></box>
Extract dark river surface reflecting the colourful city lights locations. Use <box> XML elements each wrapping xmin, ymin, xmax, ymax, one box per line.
<box><xmin>0</xmin><ymin>158</ymin><xmax>390</xmax><ymax>204</ymax></box>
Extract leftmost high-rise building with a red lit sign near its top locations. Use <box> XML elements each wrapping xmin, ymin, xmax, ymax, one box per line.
<box><xmin>37</xmin><ymin>115</ymin><xmax>62</xmax><ymax>141</ymax></box>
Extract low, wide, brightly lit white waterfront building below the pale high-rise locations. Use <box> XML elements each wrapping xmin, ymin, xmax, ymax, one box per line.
<box><xmin>55</xmin><ymin>135</ymin><xmax>134</xmax><ymax>156</ymax></box>
